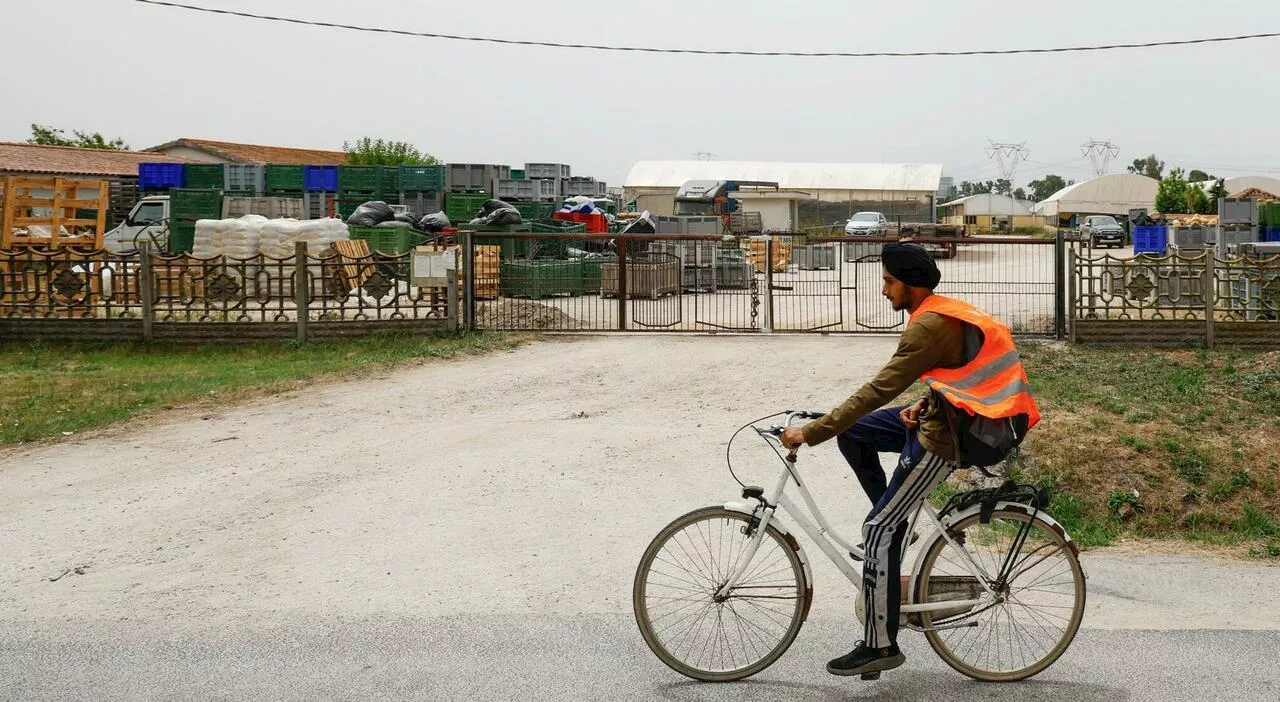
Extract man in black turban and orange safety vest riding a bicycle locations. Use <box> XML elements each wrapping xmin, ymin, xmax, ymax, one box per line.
<box><xmin>782</xmin><ymin>243</ymin><xmax>1039</xmax><ymax>675</ymax></box>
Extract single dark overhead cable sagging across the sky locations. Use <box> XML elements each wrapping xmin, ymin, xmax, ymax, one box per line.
<box><xmin>133</xmin><ymin>0</ymin><xmax>1280</xmax><ymax>59</ymax></box>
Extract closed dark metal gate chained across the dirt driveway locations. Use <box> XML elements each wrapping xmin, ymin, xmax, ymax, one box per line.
<box><xmin>462</xmin><ymin>233</ymin><xmax>1071</xmax><ymax>337</ymax></box>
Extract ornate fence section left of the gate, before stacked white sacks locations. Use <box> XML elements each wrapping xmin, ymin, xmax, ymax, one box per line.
<box><xmin>0</xmin><ymin>243</ymin><xmax>461</xmax><ymax>342</ymax></box>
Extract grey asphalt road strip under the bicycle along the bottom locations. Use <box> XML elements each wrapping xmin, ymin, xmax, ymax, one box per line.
<box><xmin>0</xmin><ymin>612</ymin><xmax>1280</xmax><ymax>702</ymax></box>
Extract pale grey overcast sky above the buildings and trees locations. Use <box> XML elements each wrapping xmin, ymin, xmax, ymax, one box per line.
<box><xmin>0</xmin><ymin>0</ymin><xmax>1280</xmax><ymax>184</ymax></box>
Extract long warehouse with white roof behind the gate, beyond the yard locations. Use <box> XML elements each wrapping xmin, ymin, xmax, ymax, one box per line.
<box><xmin>623</xmin><ymin>161</ymin><xmax>942</xmax><ymax>231</ymax></box>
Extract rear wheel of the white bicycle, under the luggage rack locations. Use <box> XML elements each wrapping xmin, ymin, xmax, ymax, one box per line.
<box><xmin>914</xmin><ymin>509</ymin><xmax>1085</xmax><ymax>682</ymax></box>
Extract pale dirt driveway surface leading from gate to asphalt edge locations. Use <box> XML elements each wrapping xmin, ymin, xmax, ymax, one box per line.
<box><xmin>0</xmin><ymin>336</ymin><xmax>1280</xmax><ymax>628</ymax></box>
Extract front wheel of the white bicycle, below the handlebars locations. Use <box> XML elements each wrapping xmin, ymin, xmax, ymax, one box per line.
<box><xmin>631</xmin><ymin>507</ymin><xmax>810</xmax><ymax>682</ymax></box>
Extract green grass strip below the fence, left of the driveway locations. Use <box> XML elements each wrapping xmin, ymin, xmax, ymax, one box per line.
<box><xmin>0</xmin><ymin>332</ymin><xmax>527</xmax><ymax>445</ymax></box>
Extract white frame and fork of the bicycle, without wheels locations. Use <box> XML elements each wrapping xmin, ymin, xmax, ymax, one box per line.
<box><xmin>716</xmin><ymin>434</ymin><xmax>996</xmax><ymax>620</ymax></box>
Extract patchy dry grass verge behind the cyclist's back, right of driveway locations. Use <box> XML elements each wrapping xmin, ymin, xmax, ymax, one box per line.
<box><xmin>998</xmin><ymin>345</ymin><xmax>1280</xmax><ymax>559</ymax></box>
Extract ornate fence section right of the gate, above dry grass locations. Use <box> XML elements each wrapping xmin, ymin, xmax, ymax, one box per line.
<box><xmin>1069</xmin><ymin>251</ymin><xmax>1280</xmax><ymax>347</ymax></box>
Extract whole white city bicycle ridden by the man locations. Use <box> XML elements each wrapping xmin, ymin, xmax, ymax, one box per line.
<box><xmin>632</xmin><ymin>412</ymin><xmax>1085</xmax><ymax>682</ymax></box>
